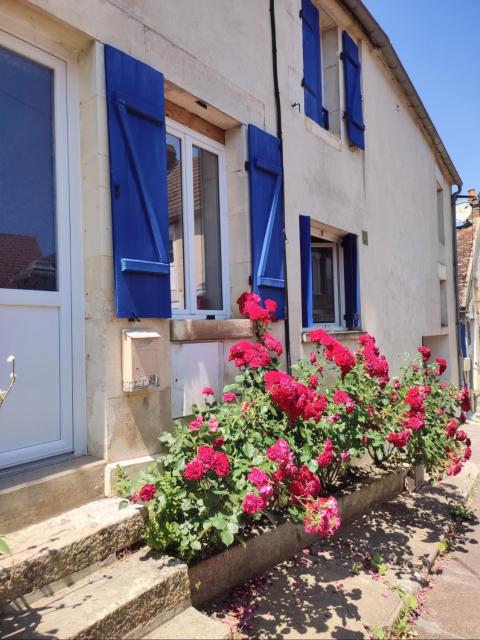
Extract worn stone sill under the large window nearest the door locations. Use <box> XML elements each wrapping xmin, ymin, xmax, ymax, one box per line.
<box><xmin>170</xmin><ymin>319</ymin><xmax>253</xmax><ymax>342</ymax></box>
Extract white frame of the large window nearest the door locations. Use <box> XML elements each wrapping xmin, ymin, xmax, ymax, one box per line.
<box><xmin>166</xmin><ymin>118</ymin><xmax>230</xmax><ymax>319</ymax></box>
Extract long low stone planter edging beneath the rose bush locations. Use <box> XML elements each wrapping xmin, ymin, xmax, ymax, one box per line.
<box><xmin>188</xmin><ymin>468</ymin><xmax>408</xmax><ymax>607</ymax></box>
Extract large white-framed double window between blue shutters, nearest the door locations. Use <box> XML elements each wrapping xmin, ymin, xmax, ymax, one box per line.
<box><xmin>167</xmin><ymin>121</ymin><xmax>228</xmax><ymax>317</ymax></box>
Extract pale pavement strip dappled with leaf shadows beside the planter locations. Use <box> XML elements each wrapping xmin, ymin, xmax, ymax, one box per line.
<box><xmin>206</xmin><ymin>425</ymin><xmax>480</xmax><ymax>640</ymax></box>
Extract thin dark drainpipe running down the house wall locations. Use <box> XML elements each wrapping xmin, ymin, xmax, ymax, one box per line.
<box><xmin>270</xmin><ymin>0</ymin><xmax>292</xmax><ymax>373</ymax></box>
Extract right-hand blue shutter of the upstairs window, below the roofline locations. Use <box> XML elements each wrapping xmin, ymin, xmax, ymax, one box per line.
<box><xmin>342</xmin><ymin>31</ymin><xmax>365</xmax><ymax>149</ymax></box>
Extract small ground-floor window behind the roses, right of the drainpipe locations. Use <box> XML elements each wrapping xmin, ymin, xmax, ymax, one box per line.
<box><xmin>312</xmin><ymin>238</ymin><xmax>343</xmax><ymax>327</ymax></box>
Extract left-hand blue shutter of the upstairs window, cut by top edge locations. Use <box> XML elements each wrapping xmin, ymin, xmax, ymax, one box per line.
<box><xmin>302</xmin><ymin>0</ymin><xmax>325</xmax><ymax>127</ymax></box>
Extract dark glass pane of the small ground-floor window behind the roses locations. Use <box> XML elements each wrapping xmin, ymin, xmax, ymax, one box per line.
<box><xmin>312</xmin><ymin>247</ymin><xmax>335</xmax><ymax>322</ymax></box>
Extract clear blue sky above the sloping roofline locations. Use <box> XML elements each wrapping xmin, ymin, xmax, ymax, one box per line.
<box><xmin>363</xmin><ymin>0</ymin><xmax>480</xmax><ymax>193</ymax></box>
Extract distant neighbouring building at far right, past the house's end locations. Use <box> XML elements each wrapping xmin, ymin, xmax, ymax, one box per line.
<box><xmin>457</xmin><ymin>189</ymin><xmax>480</xmax><ymax>408</ymax></box>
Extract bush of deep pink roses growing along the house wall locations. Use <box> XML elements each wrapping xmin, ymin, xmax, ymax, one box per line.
<box><xmin>120</xmin><ymin>293</ymin><xmax>471</xmax><ymax>561</ymax></box>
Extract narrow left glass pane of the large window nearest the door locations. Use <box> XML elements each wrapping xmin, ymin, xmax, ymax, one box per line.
<box><xmin>167</xmin><ymin>133</ymin><xmax>185</xmax><ymax>309</ymax></box>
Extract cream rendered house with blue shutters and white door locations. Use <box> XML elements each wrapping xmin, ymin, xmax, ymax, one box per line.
<box><xmin>0</xmin><ymin>0</ymin><xmax>461</xmax><ymax>482</ymax></box>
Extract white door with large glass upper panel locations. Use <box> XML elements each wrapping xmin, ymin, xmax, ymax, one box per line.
<box><xmin>0</xmin><ymin>31</ymin><xmax>73</xmax><ymax>469</ymax></box>
